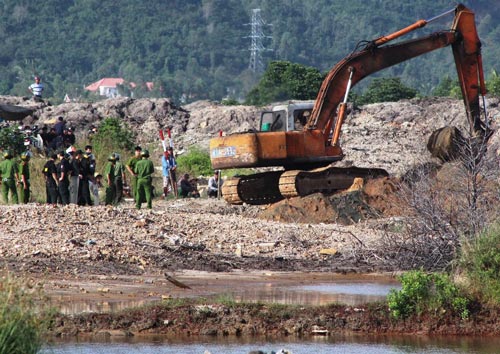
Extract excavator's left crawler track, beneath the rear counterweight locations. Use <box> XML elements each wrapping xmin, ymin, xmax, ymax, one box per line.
<box><xmin>222</xmin><ymin>171</ymin><xmax>283</xmax><ymax>205</ymax></box>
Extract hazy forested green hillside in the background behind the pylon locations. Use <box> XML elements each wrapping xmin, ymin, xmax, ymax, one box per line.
<box><xmin>0</xmin><ymin>0</ymin><xmax>500</xmax><ymax>101</ymax></box>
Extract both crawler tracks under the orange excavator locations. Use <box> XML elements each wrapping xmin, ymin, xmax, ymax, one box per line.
<box><xmin>222</xmin><ymin>167</ymin><xmax>389</xmax><ymax>205</ymax></box>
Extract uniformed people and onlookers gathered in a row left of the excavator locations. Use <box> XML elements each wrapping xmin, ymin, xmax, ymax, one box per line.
<box><xmin>0</xmin><ymin>138</ymin><xmax>222</xmax><ymax>209</ymax></box>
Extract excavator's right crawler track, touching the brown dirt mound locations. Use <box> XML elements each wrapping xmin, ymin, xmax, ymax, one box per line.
<box><xmin>279</xmin><ymin>167</ymin><xmax>389</xmax><ymax>198</ymax></box>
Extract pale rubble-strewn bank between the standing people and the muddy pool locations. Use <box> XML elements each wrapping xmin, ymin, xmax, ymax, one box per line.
<box><xmin>0</xmin><ymin>199</ymin><xmax>390</xmax><ymax>274</ymax></box>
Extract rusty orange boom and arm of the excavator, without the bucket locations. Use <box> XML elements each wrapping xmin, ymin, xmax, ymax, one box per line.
<box><xmin>310</xmin><ymin>5</ymin><xmax>486</xmax><ymax>145</ymax></box>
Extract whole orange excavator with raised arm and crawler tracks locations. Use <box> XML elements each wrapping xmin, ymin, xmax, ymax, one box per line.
<box><xmin>210</xmin><ymin>4</ymin><xmax>489</xmax><ymax>204</ymax></box>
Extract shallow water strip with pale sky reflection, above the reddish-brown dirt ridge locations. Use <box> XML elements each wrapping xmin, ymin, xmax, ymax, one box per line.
<box><xmin>51</xmin><ymin>277</ymin><xmax>400</xmax><ymax>314</ymax></box>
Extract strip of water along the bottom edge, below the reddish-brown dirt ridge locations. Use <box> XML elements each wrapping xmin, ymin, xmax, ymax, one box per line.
<box><xmin>42</xmin><ymin>336</ymin><xmax>500</xmax><ymax>354</ymax></box>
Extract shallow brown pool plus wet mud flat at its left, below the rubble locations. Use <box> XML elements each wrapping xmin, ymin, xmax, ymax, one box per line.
<box><xmin>45</xmin><ymin>272</ymin><xmax>399</xmax><ymax>314</ymax></box>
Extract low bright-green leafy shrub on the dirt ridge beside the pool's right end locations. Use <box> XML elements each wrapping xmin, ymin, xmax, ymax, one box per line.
<box><xmin>387</xmin><ymin>270</ymin><xmax>469</xmax><ymax>319</ymax></box>
